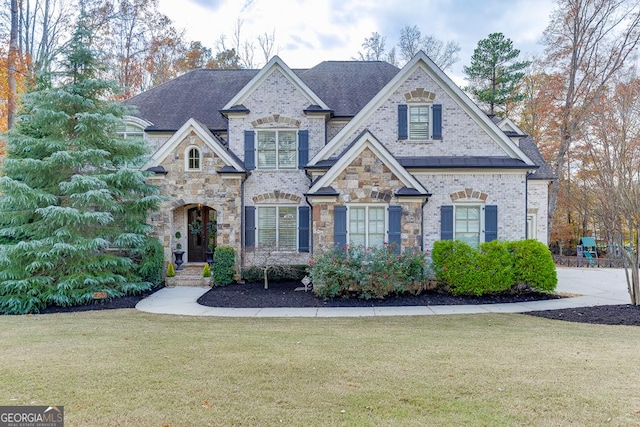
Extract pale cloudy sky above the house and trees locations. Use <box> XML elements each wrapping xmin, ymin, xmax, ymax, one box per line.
<box><xmin>159</xmin><ymin>0</ymin><xmax>555</xmax><ymax>86</ymax></box>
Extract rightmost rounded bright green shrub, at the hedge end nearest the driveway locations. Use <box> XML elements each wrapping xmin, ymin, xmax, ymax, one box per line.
<box><xmin>509</xmin><ymin>239</ymin><xmax>558</xmax><ymax>291</ymax></box>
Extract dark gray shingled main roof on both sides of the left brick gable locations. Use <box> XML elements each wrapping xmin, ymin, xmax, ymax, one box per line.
<box><xmin>124</xmin><ymin>61</ymin><xmax>399</xmax><ymax>132</ymax></box>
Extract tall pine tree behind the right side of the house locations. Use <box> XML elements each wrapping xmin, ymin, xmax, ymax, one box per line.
<box><xmin>463</xmin><ymin>33</ymin><xmax>529</xmax><ymax>114</ymax></box>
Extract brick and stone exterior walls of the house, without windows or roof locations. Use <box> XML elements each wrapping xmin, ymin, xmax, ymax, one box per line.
<box><xmin>138</xmin><ymin>51</ymin><xmax>548</xmax><ymax>280</ymax></box>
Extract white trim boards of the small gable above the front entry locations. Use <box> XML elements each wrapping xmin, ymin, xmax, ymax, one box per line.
<box><xmin>141</xmin><ymin>119</ymin><xmax>245</xmax><ymax>173</ymax></box>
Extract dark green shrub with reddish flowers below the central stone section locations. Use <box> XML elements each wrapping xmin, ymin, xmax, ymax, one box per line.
<box><xmin>309</xmin><ymin>244</ymin><xmax>430</xmax><ymax>299</ymax></box>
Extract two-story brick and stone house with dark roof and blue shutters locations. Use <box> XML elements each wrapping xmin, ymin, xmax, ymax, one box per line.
<box><xmin>126</xmin><ymin>52</ymin><xmax>553</xmax><ymax>276</ymax></box>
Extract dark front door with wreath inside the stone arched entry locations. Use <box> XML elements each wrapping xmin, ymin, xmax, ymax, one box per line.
<box><xmin>187</xmin><ymin>205</ymin><xmax>218</xmax><ymax>262</ymax></box>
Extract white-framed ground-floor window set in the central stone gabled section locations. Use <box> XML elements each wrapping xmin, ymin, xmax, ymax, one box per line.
<box><xmin>348</xmin><ymin>206</ymin><xmax>387</xmax><ymax>247</ymax></box>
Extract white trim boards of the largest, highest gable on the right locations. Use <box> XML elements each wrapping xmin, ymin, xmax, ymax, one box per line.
<box><xmin>309</xmin><ymin>51</ymin><xmax>534</xmax><ymax>166</ymax></box>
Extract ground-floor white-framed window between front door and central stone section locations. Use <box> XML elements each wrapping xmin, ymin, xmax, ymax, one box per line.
<box><xmin>256</xmin><ymin>206</ymin><xmax>298</xmax><ymax>251</ymax></box>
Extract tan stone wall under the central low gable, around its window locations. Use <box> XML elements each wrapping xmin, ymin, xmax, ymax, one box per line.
<box><xmin>313</xmin><ymin>149</ymin><xmax>422</xmax><ymax>252</ymax></box>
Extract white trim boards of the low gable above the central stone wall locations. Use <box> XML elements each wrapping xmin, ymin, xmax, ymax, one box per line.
<box><xmin>307</xmin><ymin>130</ymin><xmax>429</xmax><ymax>196</ymax></box>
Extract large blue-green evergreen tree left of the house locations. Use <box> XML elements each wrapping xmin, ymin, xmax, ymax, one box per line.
<box><xmin>0</xmin><ymin>18</ymin><xmax>162</xmax><ymax>314</ymax></box>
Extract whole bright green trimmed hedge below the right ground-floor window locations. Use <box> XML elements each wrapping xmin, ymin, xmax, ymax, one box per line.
<box><xmin>432</xmin><ymin>239</ymin><xmax>558</xmax><ymax>295</ymax></box>
